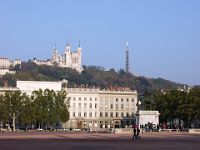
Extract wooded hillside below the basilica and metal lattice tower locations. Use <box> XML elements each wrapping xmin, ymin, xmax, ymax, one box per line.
<box><xmin>0</xmin><ymin>62</ymin><xmax>182</xmax><ymax>94</ymax></box>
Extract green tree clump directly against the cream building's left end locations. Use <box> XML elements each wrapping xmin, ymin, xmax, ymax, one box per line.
<box><xmin>33</xmin><ymin>89</ymin><xmax>69</xmax><ymax>128</ymax></box>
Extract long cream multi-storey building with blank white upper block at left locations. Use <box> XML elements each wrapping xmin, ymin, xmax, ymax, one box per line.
<box><xmin>17</xmin><ymin>81</ymin><xmax>138</xmax><ymax>130</ymax></box>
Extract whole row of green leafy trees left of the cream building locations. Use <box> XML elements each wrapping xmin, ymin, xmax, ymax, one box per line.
<box><xmin>0</xmin><ymin>89</ymin><xmax>69</xmax><ymax>131</ymax></box>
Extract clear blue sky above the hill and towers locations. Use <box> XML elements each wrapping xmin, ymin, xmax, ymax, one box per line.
<box><xmin>0</xmin><ymin>0</ymin><xmax>200</xmax><ymax>85</ymax></box>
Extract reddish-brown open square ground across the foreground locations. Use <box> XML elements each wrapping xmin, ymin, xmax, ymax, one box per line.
<box><xmin>0</xmin><ymin>132</ymin><xmax>200</xmax><ymax>150</ymax></box>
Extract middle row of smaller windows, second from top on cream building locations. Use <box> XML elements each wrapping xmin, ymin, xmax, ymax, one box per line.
<box><xmin>73</xmin><ymin>103</ymin><xmax>133</xmax><ymax>109</ymax></box>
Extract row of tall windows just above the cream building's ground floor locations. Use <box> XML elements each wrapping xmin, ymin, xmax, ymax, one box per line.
<box><xmin>73</xmin><ymin>112</ymin><xmax>134</xmax><ymax>117</ymax></box>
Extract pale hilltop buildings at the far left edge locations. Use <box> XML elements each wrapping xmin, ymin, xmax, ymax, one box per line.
<box><xmin>0</xmin><ymin>57</ymin><xmax>21</xmax><ymax>76</ymax></box>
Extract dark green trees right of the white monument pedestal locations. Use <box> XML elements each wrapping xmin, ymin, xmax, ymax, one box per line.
<box><xmin>141</xmin><ymin>87</ymin><xmax>200</xmax><ymax>128</ymax></box>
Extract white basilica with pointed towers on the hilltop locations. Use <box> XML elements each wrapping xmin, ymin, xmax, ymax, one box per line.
<box><xmin>33</xmin><ymin>43</ymin><xmax>82</xmax><ymax>73</ymax></box>
